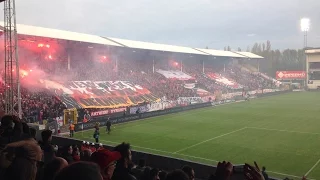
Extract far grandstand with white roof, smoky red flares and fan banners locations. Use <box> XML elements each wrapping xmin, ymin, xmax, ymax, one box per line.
<box><xmin>0</xmin><ymin>21</ymin><xmax>270</xmax><ymax>121</ymax></box>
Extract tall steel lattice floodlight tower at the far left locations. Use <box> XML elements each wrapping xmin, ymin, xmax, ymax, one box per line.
<box><xmin>0</xmin><ymin>0</ymin><xmax>22</xmax><ymax>118</ymax></box>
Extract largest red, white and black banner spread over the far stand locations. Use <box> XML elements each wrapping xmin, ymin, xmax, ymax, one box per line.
<box><xmin>40</xmin><ymin>80</ymin><xmax>160</xmax><ymax>108</ymax></box>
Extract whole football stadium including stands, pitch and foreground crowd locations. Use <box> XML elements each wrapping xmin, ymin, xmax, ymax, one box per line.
<box><xmin>0</xmin><ymin>2</ymin><xmax>320</xmax><ymax>180</ymax></box>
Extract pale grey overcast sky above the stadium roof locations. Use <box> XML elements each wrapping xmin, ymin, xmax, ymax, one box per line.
<box><xmin>6</xmin><ymin>0</ymin><xmax>320</xmax><ymax>49</ymax></box>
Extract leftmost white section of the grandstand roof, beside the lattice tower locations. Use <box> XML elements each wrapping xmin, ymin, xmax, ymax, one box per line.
<box><xmin>0</xmin><ymin>21</ymin><xmax>121</xmax><ymax>46</ymax></box>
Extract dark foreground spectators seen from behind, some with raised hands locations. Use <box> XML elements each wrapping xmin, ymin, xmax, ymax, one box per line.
<box><xmin>0</xmin><ymin>115</ymin><xmax>276</xmax><ymax>180</ymax></box>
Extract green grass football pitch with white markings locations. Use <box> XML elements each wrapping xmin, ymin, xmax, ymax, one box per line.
<box><xmin>75</xmin><ymin>92</ymin><xmax>320</xmax><ymax>179</ymax></box>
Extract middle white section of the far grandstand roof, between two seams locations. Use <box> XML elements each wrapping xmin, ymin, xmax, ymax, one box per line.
<box><xmin>106</xmin><ymin>37</ymin><xmax>208</xmax><ymax>55</ymax></box>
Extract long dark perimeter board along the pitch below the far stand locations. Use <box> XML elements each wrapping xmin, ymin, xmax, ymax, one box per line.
<box><xmin>75</xmin><ymin>103</ymin><xmax>211</xmax><ymax>131</ymax></box>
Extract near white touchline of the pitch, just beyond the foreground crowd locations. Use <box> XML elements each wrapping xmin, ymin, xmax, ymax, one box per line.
<box><xmin>80</xmin><ymin>137</ymin><xmax>315</xmax><ymax>180</ymax></box>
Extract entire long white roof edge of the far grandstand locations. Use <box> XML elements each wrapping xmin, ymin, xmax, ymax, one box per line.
<box><xmin>0</xmin><ymin>21</ymin><xmax>263</xmax><ymax>58</ymax></box>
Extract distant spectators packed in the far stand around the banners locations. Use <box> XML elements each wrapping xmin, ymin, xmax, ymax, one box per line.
<box><xmin>0</xmin><ymin>59</ymin><xmax>274</xmax><ymax>123</ymax></box>
